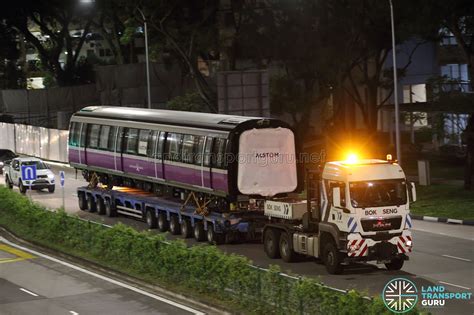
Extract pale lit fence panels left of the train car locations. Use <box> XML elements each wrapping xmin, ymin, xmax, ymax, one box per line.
<box><xmin>0</xmin><ymin>123</ymin><xmax>69</xmax><ymax>162</ymax></box>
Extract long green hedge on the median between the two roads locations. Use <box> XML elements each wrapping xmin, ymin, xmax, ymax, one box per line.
<box><xmin>0</xmin><ymin>187</ymin><xmax>417</xmax><ymax>314</ymax></box>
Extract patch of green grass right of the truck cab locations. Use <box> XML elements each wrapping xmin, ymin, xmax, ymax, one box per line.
<box><xmin>411</xmin><ymin>184</ymin><xmax>474</xmax><ymax>220</ymax></box>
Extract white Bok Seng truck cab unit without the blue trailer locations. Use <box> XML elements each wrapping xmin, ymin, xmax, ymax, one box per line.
<box><xmin>263</xmin><ymin>159</ymin><xmax>416</xmax><ymax>273</ymax></box>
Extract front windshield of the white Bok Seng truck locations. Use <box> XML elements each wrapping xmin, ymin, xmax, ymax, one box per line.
<box><xmin>349</xmin><ymin>179</ymin><xmax>407</xmax><ymax>208</ymax></box>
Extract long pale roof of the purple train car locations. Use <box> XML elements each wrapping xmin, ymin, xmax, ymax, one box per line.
<box><xmin>75</xmin><ymin>106</ymin><xmax>278</xmax><ymax>131</ymax></box>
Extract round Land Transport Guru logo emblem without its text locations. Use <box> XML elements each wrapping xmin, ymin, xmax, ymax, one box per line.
<box><xmin>382</xmin><ymin>278</ymin><xmax>418</xmax><ymax>314</ymax></box>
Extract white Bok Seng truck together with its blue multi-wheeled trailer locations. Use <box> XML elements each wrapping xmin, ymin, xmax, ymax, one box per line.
<box><xmin>77</xmin><ymin>159</ymin><xmax>416</xmax><ymax>274</ymax></box>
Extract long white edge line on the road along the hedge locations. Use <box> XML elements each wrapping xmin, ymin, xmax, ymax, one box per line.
<box><xmin>0</xmin><ymin>237</ymin><xmax>205</xmax><ymax>315</ymax></box>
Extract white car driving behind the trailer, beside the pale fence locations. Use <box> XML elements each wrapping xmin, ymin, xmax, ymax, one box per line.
<box><xmin>4</xmin><ymin>157</ymin><xmax>55</xmax><ymax>194</ymax></box>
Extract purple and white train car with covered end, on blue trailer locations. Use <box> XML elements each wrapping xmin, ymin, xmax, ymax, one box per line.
<box><xmin>68</xmin><ymin>106</ymin><xmax>297</xmax><ymax>209</ymax></box>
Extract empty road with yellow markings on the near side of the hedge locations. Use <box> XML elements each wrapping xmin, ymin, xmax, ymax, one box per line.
<box><xmin>0</xmin><ymin>237</ymin><xmax>204</xmax><ymax>315</ymax></box>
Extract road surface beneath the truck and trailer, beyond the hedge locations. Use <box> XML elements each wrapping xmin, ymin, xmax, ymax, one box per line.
<box><xmin>0</xmin><ymin>167</ymin><xmax>474</xmax><ymax>314</ymax></box>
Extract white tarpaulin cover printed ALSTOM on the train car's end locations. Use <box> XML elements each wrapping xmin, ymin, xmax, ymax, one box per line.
<box><xmin>237</xmin><ymin>127</ymin><xmax>297</xmax><ymax>197</ymax></box>
